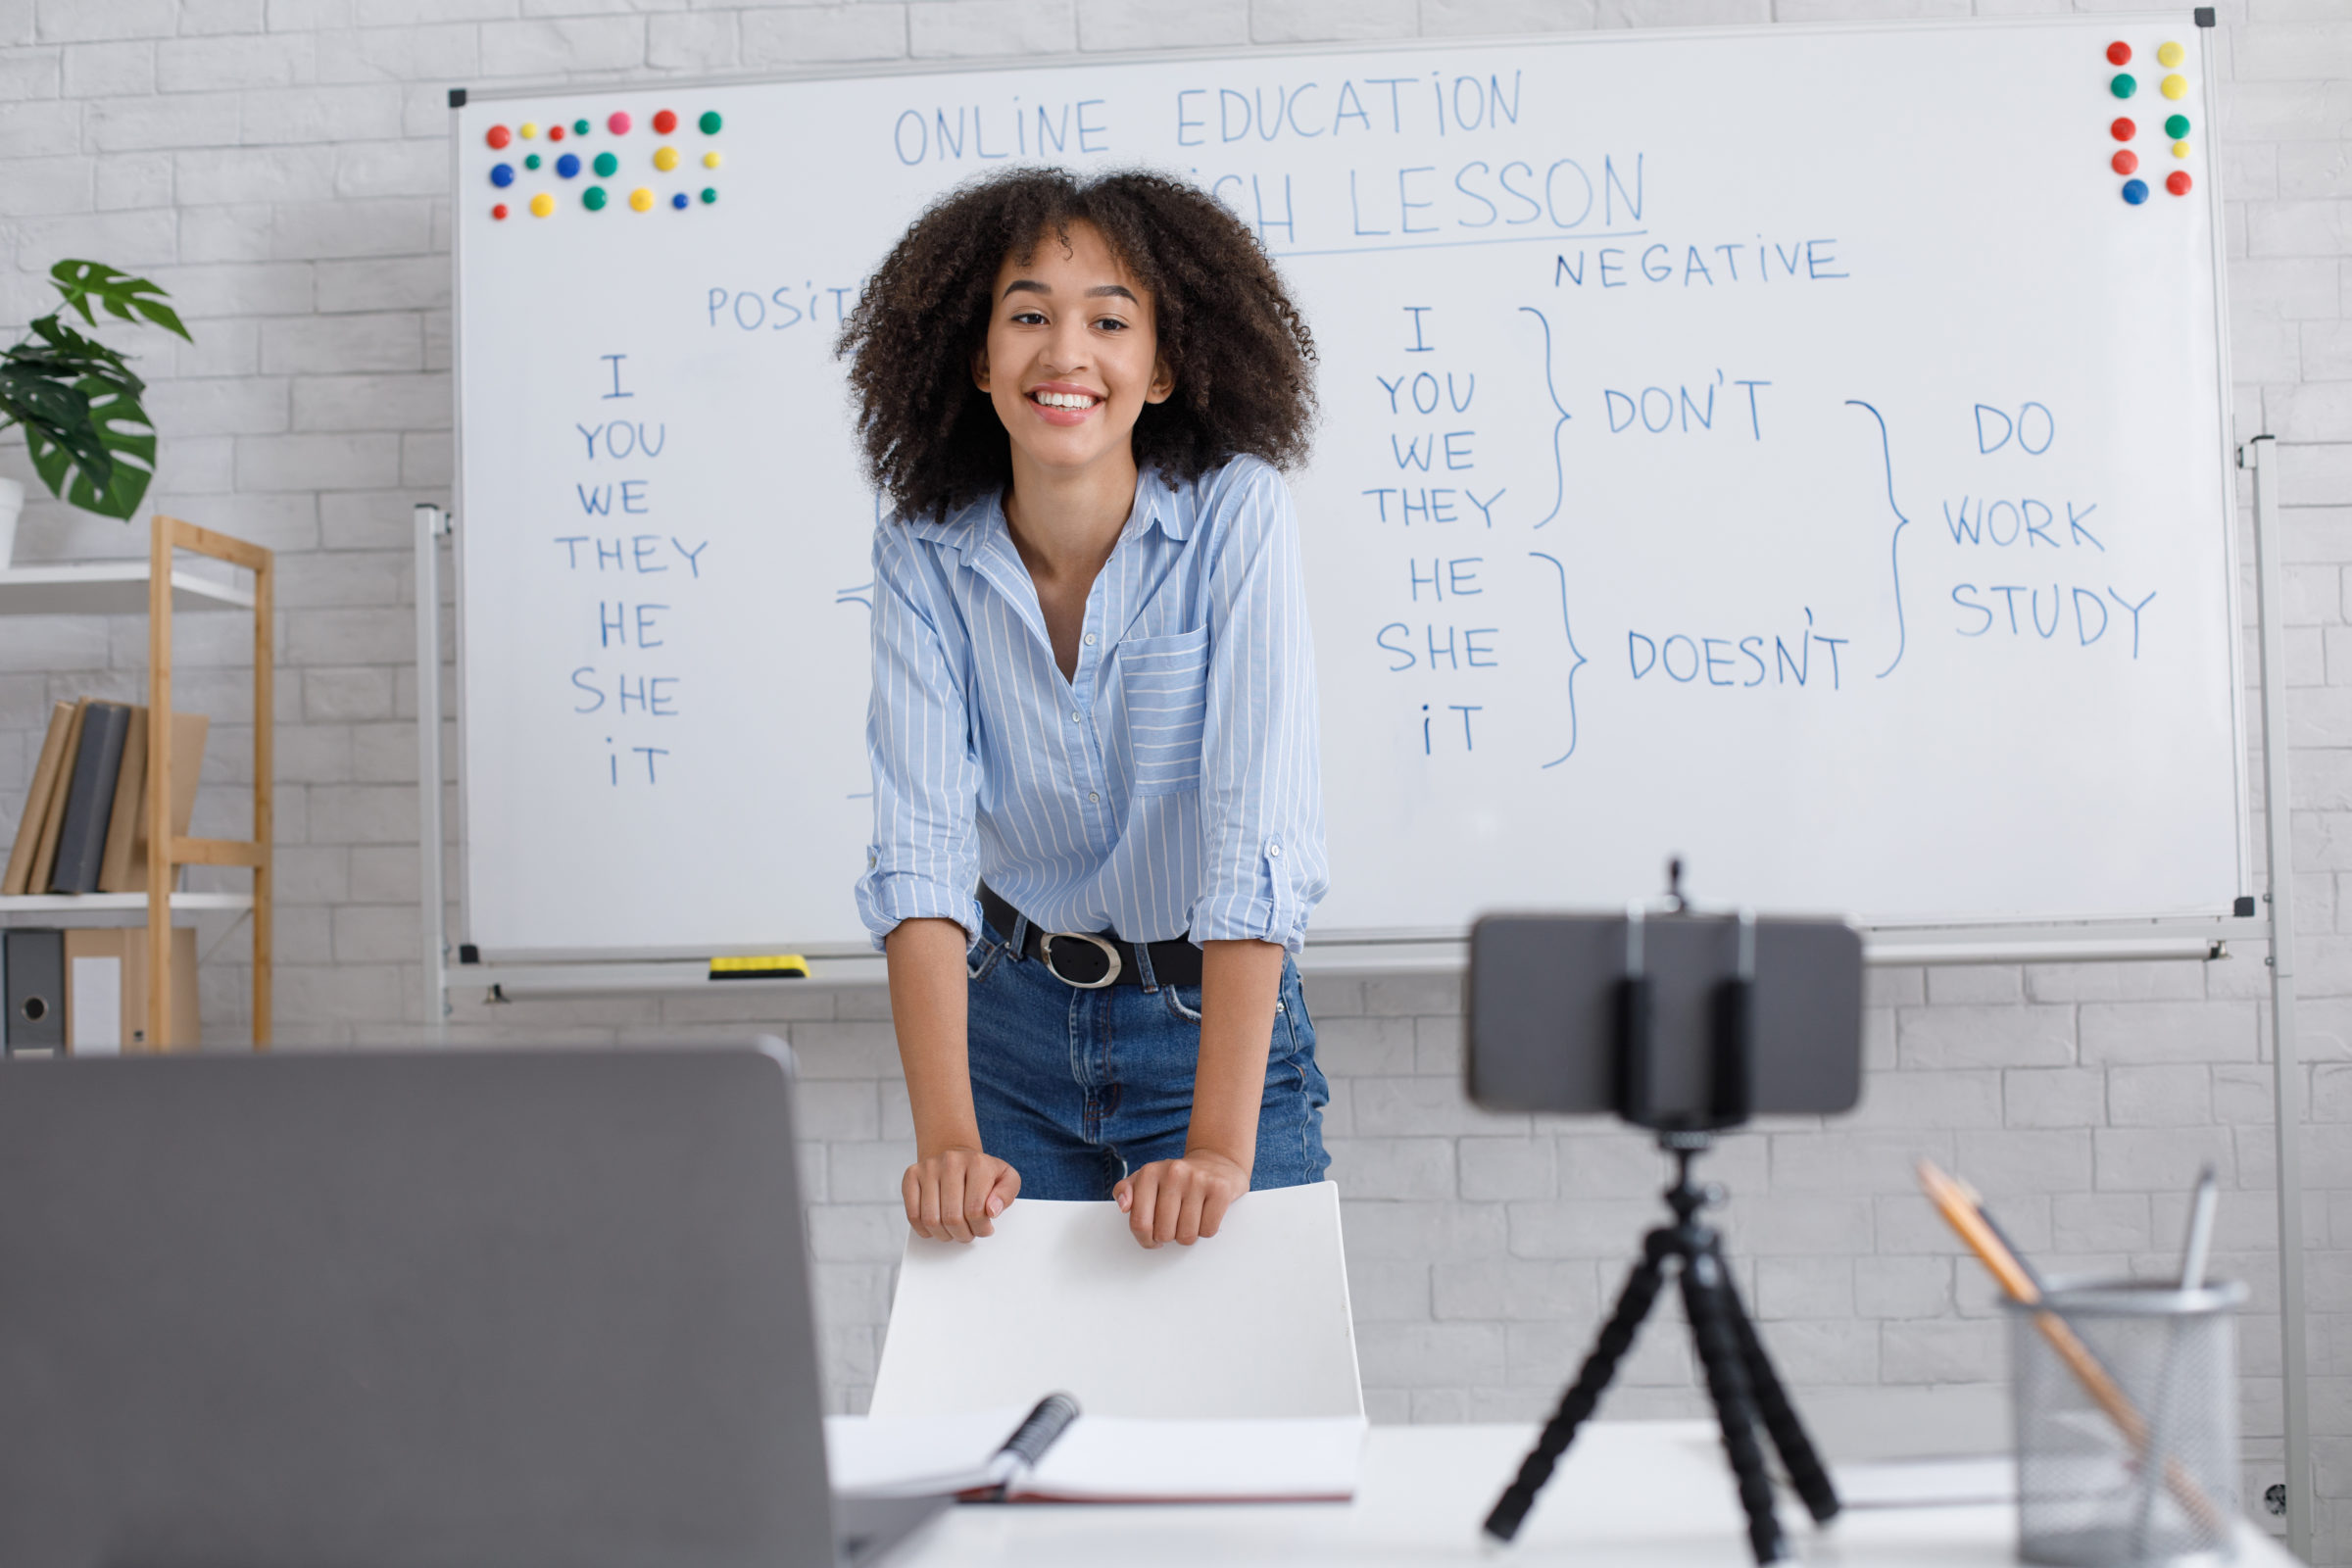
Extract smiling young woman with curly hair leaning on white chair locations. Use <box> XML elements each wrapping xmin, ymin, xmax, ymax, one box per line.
<box><xmin>842</xmin><ymin>170</ymin><xmax>1329</xmax><ymax>1246</ymax></box>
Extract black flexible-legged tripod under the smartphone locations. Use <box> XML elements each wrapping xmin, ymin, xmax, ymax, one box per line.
<box><xmin>1487</xmin><ymin>1131</ymin><xmax>1837</xmax><ymax>1563</ymax></box>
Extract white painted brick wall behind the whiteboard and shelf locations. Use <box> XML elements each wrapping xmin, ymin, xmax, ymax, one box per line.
<box><xmin>0</xmin><ymin>0</ymin><xmax>2352</xmax><ymax>1563</ymax></box>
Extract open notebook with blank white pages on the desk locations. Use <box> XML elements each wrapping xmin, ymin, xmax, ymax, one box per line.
<box><xmin>825</xmin><ymin>1405</ymin><xmax>1364</xmax><ymax>1502</ymax></box>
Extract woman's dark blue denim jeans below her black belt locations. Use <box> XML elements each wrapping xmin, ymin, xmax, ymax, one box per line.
<box><xmin>969</xmin><ymin>926</ymin><xmax>1331</xmax><ymax>1201</ymax></box>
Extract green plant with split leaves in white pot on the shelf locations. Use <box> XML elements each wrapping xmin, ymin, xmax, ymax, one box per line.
<box><xmin>0</xmin><ymin>261</ymin><xmax>193</xmax><ymax>566</ymax></box>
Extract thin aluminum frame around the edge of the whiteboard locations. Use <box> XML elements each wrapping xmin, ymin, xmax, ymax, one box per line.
<box><xmin>444</xmin><ymin>10</ymin><xmax>2268</xmax><ymax>971</ymax></box>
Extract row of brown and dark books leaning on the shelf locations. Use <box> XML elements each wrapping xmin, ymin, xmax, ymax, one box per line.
<box><xmin>0</xmin><ymin>698</ymin><xmax>210</xmax><ymax>894</ymax></box>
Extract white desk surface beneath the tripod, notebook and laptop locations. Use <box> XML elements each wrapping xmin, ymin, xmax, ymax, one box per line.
<box><xmin>894</xmin><ymin>1422</ymin><xmax>2295</xmax><ymax>1568</ymax></box>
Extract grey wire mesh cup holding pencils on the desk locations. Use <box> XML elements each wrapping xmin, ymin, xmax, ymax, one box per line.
<box><xmin>2004</xmin><ymin>1279</ymin><xmax>2246</xmax><ymax>1568</ymax></box>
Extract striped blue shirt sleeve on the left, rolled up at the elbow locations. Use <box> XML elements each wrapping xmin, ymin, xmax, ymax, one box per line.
<box><xmin>857</xmin><ymin>522</ymin><xmax>981</xmax><ymax>948</ymax></box>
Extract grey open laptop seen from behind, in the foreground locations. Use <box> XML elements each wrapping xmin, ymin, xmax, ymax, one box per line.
<box><xmin>0</xmin><ymin>1042</ymin><xmax>943</xmax><ymax>1568</ymax></box>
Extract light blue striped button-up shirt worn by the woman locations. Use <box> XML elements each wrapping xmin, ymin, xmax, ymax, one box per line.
<box><xmin>858</xmin><ymin>456</ymin><xmax>1329</xmax><ymax>953</ymax></box>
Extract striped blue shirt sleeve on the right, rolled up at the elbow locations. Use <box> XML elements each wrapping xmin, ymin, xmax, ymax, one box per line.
<box><xmin>1193</xmin><ymin>464</ymin><xmax>1329</xmax><ymax>953</ymax></box>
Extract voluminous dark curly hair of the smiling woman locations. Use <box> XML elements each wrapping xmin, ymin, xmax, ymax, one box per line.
<box><xmin>835</xmin><ymin>170</ymin><xmax>1315</xmax><ymax>517</ymax></box>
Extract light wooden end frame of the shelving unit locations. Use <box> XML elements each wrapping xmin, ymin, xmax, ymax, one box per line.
<box><xmin>146</xmin><ymin>513</ymin><xmax>277</xmax><ymax>1051</ymax></box>
